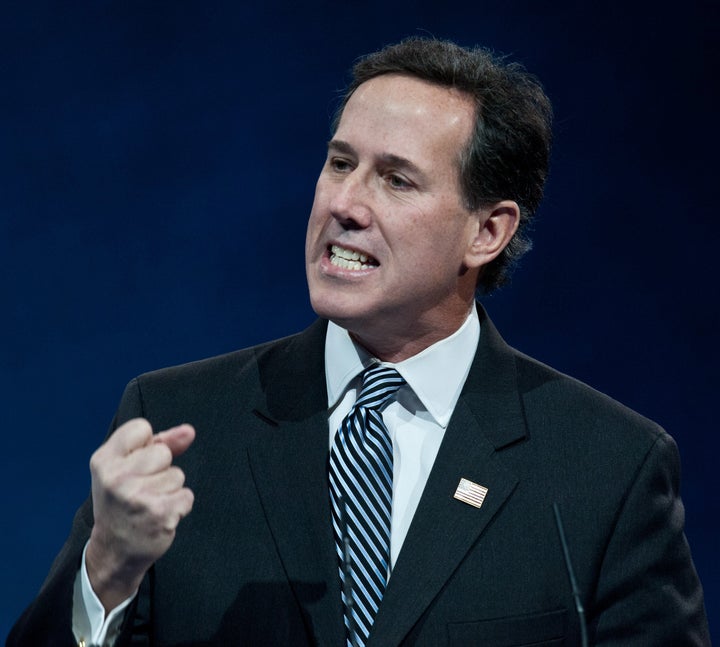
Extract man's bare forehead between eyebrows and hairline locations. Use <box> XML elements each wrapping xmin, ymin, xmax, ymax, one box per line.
<box><xmin>335</xmin><ymin>74</ymin><xmax>475</xmax><ymax>172</ymax></box>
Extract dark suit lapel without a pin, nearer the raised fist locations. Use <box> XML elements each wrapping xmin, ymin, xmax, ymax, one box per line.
<box><xmin>243</xmin><ymin>322</ymin><xmax>344</xmax><ymax>645</ymax></box>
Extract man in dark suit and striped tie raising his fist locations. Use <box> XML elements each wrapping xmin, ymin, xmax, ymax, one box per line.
<box><xmin>8</xmin><ymin>39</ymin><xmax>709</xmax><ymax>647</ymax></box>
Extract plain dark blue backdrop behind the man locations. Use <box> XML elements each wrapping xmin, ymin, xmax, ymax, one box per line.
<box><xmin>0</xmin><ymin>0</ymin><xmax>720</xmax><ymax>636</ymax></box>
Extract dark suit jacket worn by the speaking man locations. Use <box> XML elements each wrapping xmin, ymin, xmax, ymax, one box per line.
<box><xmin>7</xmin><ymin>310</ymin><xmax>710</xmax><ymax>647</ymax></box>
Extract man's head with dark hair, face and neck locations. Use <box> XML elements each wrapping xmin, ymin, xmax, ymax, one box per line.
<box><xmin>306</xmin><ymin>41</ymin><xmax>549</xmax><ymax>361</ymax></box>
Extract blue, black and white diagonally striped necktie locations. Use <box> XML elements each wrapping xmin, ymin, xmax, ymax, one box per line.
<box><xmin>330</xmin><ymin>365</ymin><xmax>405</xmax><ymax>647</ymax></box>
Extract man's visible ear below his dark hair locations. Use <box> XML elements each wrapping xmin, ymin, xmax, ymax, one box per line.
<box><xmin>464</xmin><ymin>200</ymin><xmax>520</xmax><ymax>268</ymax></box>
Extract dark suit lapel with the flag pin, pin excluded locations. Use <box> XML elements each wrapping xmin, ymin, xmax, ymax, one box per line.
<box><xmin>368</xmin><ymin>308</ymin><xmax>526</xmax><ymax>647</ymax></box>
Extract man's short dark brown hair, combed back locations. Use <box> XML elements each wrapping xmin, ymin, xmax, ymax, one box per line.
<box><xmin>333</xmin><ymin>38</ymin><xmax>552</xmax><ymax>293</ymax></box>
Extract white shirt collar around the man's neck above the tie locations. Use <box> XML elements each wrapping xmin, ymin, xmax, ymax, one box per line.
<box><xmin>325</xmin><ymin>308</ymin><xmax>480</xmax><ymax>428</ymax></box>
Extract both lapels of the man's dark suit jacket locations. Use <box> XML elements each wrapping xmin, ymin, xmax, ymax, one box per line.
<box><xmin>243</xmin><ymin>306</ymin><xmax>526</xmax><ymax>647</ymax></box>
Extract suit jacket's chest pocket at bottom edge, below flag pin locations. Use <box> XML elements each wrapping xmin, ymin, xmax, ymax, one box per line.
<box><xmin>448</xmin><ymin>609</ymin><xmax>567</xmax><ymax>647</ymax></box>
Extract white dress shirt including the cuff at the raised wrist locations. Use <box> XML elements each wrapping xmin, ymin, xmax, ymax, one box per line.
<box><xmin>73</xmin><ymin>308</ymin><xmax>480</xmax><ymax>647</ymax></box>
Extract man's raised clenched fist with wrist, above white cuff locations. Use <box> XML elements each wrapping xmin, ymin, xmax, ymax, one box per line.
<box><xmin>85</xmin><ymin>418</ymin><xmax>195</xmax><ymax>612</ymax></box>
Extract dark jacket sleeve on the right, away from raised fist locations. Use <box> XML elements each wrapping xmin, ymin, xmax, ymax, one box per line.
<box><xmin>590</xmin><ymin>432</ymin><xmax>710</xmax><ymax>647</ymax></box>
